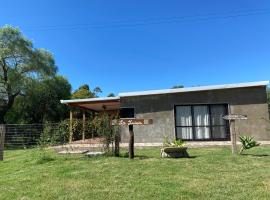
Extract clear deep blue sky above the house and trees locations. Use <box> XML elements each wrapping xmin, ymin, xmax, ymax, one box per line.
<box><xmin>0</xmin><ymin>0</ymin><xmax>270</xmax><ymax>96</ymax></box>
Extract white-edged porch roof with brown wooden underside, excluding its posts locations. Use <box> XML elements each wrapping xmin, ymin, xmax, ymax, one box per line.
<box><xmin>60</xmin><ymin>97</ymin><xmax>120</xmax><ymax>112</ymax></box>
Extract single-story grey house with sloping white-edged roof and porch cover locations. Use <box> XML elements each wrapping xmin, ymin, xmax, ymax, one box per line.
<box><xmin>61</xmin><ymin>81</ymin><xmax>270</xmax><ymax>143</ymax></box>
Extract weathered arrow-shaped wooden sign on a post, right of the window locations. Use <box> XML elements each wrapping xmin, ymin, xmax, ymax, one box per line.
<box><xmin>223</xmin><ymin>114</ymin><xmax>247</xmax><ymax>154</ymax></box>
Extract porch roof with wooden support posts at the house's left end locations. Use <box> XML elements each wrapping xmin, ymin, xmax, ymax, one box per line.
<box><xmin>61</xmin><ymin>97</ymin><xmax>120</xmax><ymax>142</ymax></box>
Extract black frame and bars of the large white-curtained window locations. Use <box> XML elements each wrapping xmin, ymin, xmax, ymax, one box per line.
<box><xmin>174</xmin><ymin>103</ymin><xmax>231</xmax><ymax>141</ymax></box>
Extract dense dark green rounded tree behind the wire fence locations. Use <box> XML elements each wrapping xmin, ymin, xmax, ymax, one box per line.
<box><xmin>6</xmin><ymin>76</ymin><xmax>71</xmax><ymax>123</ymax></box>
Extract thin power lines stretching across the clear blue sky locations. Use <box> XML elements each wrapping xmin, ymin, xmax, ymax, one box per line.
<box><xmin>21</xmin><ymin>9</ymin><xmax>270</xmax><ymax>31</ymax></box>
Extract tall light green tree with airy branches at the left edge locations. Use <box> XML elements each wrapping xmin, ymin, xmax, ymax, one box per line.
<box><xmin>0</xmin><ymin>26</ymin><xmax>57</xmax><ymax>123</ymax></box>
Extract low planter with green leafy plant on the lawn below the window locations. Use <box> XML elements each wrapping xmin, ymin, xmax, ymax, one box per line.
<box><xmin>160</xmin><ymin>137</ymin><xmax>189</xmax><ymax>158</ymax></box>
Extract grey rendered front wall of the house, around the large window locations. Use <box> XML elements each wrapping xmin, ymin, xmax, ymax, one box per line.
<box><xmin>120</xmin><ymin>86</ymin><xmax>270</xmax><ymax>143</ymax></box>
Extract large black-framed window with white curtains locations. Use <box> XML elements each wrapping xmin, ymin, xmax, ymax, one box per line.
<box><xmin>175</xmin><ymin>104</ymin><xmax>229</xmax><ymax>140</ymax></box>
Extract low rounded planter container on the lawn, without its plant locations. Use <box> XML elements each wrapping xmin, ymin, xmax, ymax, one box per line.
<box><xmin>160</xmin><ymin>147</ymin><xmax>189</xmax><ymax>158</ymax></box>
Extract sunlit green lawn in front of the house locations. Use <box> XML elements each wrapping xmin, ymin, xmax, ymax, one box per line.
<box><xmin>0</xmin><ymin>147</ymin><xmax>270</xmax><ymax>200</ymax></box>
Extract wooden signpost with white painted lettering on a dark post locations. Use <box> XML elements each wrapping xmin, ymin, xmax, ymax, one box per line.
<box><xmin>112</xmin><ymin>118</ymin><xmax>153</xmax><ymax>159</ymax></box>
